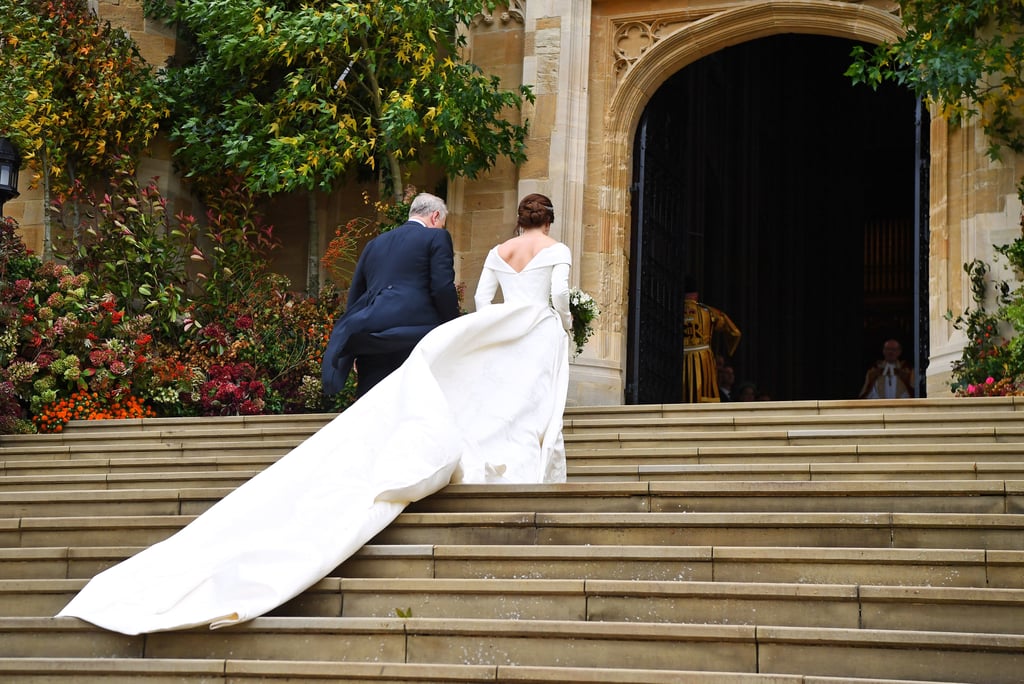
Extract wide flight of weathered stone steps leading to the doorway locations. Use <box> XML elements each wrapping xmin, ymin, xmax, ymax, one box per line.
<box><xmin>0</xmin><ymin>397</ymin><xmax>1024</xmax><ymax>684</ymax></box>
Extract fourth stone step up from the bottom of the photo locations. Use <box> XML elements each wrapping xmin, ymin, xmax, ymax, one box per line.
<box><xmin>0</xmin><ymin>544</ymin><xmax>1024</xmax><ymax>589</ymax></box>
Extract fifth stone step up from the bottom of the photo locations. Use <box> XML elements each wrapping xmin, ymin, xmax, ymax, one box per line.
<box><xmin>0</xmin><ymin>511</ymin><xmax>1024</xmax><ymax>550</ymax></box>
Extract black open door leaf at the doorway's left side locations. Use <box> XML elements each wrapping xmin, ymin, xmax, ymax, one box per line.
<box><xmin>626</xmin><ymin>108</ymin><xmax>686</xmax><ymax>403</ymax></box>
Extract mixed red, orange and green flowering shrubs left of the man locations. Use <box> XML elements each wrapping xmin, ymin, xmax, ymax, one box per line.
<box><xmin>0</xmin><ymin>176</ymin><xmax>354</xmax><ymax>433</ymax></box>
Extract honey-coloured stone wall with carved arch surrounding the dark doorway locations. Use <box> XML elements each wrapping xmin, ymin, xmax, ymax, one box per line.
<box><xmin>5</xmin><ymin>0</ymin><xmax>1024</xmax><ymax>404</ymax></box>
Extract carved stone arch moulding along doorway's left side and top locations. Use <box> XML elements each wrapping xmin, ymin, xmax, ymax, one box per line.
<box><xmin>586</xmin><ymin>2</ymin><xmax>900</xmax><ymax>401</ymax></box>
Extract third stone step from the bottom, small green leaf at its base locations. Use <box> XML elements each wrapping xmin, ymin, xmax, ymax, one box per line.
<box><xmin>8</xmin><ymin>578</ymin><xmax>1024</xmax><ymax>634</ymax></box>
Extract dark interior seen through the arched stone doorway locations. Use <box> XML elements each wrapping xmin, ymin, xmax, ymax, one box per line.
<box><xmin>626</xmin><ymin>35</ymin><xmax>927</xmax><ymax>403</ymax></box>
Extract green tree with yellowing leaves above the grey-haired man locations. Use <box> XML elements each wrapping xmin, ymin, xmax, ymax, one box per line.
<box><xmin>147</xmin><ymin>0</ymin><xmax>532</xmax><ymax>201</ymax></box>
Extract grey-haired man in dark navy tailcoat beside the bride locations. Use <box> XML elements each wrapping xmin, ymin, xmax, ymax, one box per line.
<box><xmin>322</xmin><ymin>193</ymin><xmax>459</xmax><ymax>396</ymax></box>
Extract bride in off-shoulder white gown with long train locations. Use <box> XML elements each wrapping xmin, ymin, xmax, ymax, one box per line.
<box><xmin>57</xmin><ymin>195</ymin><xmax>571</xmax><ymax>634</ymax></box>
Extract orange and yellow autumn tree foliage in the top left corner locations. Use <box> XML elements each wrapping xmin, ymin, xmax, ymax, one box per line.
<box><xmin>0</xmin><ymin>0</ymin><xmax>166</xmax><ymax>189</ymax></box>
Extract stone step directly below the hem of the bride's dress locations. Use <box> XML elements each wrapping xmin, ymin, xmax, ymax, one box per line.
<box><xmin>0</xmin><ymin>473</ymin><xmax>1024</xmax><ymax>518</ymax></box>
